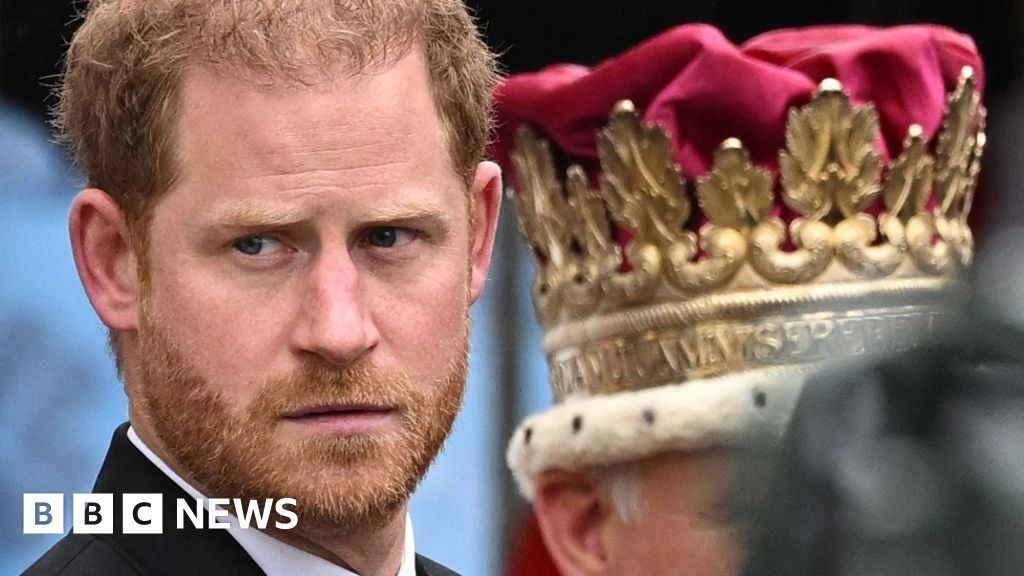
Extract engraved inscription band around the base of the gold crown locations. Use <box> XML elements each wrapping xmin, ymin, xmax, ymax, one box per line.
<box><xmin>549</xmin><ymin>306</ymin><xmax>948</xmax><ymax>402</ymax></box>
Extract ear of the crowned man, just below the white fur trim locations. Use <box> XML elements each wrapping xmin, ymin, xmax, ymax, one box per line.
<box><xmin>534</xmin><ymin>470</ymin><xmax>614</xmax><ymax>576</ymax></box>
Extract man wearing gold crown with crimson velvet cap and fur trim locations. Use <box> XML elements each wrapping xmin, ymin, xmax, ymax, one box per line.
<box><xmin>497</xmin><ymin>25</ymin><xmax>984</xmax><ymax>576</ymax></box>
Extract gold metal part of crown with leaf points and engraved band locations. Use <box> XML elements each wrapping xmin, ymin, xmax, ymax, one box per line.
<box><xmin>512</xmin><ymin>67</ymin><xmax>985</xmax><ymax>401</ymax></box>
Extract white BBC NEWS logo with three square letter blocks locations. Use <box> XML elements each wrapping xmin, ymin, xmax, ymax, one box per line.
<box><xmin>23</xmin><ymin>493</ymin><xmax>299</xmax><ymax>534</ymax></box>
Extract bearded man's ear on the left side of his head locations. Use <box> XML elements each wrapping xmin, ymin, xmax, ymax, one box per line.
<box><xmin>69</xmin><ymin>189</ymin><xmax>139</xmax><ymax>331</ymax></box>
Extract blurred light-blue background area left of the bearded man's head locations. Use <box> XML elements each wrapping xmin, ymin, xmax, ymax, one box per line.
<box><xmin>0</xmin><ymin>102</ymin><xmax>127</xmax><ymax>574</ymax></box>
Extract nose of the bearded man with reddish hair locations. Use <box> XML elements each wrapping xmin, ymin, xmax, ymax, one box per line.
<box><xmin>293</xmin><ymin>250</ymin><xmax>380</xmax><ymax>367</ymax></box>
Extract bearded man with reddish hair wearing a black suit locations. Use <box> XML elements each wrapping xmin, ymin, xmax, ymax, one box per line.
<box><xmin>22</xmin><ymin>0</ymin><xmax>501</xmax><ymax>576</ymax></box>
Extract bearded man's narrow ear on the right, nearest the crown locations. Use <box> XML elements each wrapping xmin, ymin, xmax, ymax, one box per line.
<box><xmin>469</xmin><ymin>162</ymin><xmax>502</xmax><ymax>302</ymax></box>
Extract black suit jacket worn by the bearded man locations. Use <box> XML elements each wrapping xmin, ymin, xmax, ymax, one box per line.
<box><xmin>24</xmin><ymin>423</ymin><xmax>458</xmax><ymax>576</ymax></box>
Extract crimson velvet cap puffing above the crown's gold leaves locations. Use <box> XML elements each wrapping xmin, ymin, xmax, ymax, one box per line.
<box><xmin>493</xmin><ymin>25</ymin><xmax>984</xmax><ymax>182</ymax></box>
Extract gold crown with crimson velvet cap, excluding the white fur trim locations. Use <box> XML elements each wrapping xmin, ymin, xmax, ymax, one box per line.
<box><xmin>493</xmin><ymin>25</ymin><xmax>985</xmax><ymax>400</ymax></box>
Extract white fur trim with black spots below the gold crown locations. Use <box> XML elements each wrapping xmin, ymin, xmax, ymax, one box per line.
<box><xmin>506</xmin><ymin>367</ymin><xmax>811</xmax><ymax>500</ymax></box>
